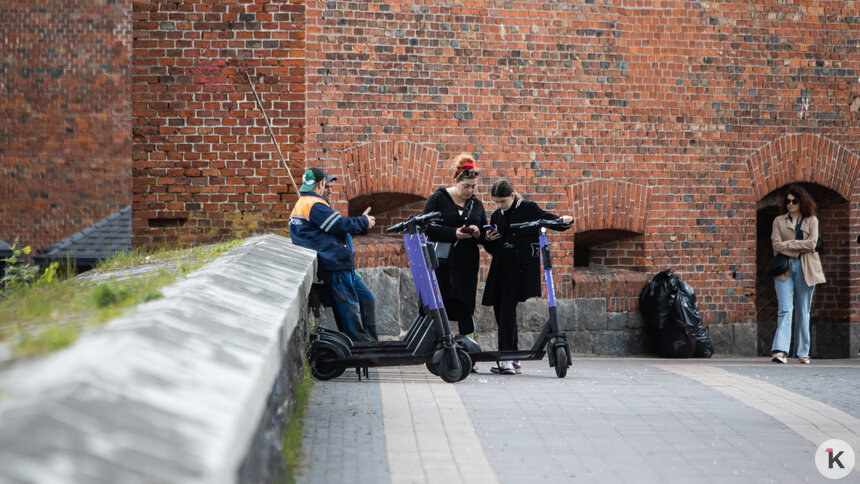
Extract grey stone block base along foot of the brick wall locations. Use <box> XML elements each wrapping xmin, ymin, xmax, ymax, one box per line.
<box><xmin>310</xmin><ymin>267</ymin><xmax>757</xmax><ymax>356</ymax></box>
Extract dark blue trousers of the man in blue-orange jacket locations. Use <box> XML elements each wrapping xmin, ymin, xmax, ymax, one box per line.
<box><xmin>320</xmin><ymin>270</ymin><xmax>379</xmax><ymax>341</ymax></box>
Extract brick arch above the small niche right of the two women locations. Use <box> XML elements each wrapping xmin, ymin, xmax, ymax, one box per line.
<box><xmin>569</xmin><ymin>179</ymin><xmax>651</xmax><ymax>234</ymax></box>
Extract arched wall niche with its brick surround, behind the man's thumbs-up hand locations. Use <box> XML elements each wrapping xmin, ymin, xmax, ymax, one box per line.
<box><xmin>340</xmin><ymin>141</ymin><xmax>439</xmax><ymax>230</ymax></box>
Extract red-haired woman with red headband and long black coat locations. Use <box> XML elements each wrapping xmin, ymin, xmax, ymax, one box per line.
<box><xmin>424</xmin><ymin>153</ymin><xmax>487</xmax><ymax>356</ymax></box>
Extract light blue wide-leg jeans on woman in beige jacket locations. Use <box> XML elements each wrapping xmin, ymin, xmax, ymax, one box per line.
<box><xmin>771</xmin><ymin>259</ymin><xmax>815</xmax><ymax>356</ymax></box>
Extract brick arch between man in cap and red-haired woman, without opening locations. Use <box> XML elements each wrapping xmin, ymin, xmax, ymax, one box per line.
<box><xmin>340</xmin><ymin>141</ymin><xmax>439</xmax><ymax>206</ymax></box>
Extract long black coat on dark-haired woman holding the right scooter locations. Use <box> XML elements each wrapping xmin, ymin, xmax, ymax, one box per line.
<box><xmin>481</xmin><ymin>198</ymin><xmax>558</xmax><ymax>306</ymax></box>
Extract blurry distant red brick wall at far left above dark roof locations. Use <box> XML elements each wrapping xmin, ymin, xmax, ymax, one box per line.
<box><xmin>0</xmin><ymin>0</ymin><xmax>131</xmax><ymax>253</ymax></box>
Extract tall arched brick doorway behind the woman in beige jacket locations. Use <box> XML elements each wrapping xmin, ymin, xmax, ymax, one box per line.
<box><xmin>747</xmin><ymin>134</ymin><xmax>860</xmax><ymax>358</ymax></box>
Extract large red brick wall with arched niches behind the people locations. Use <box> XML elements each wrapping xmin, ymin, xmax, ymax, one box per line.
<box><xmin>126</xmin><ymin>0</ymin><xmax>860</xmax><ymax>334</ymax></box>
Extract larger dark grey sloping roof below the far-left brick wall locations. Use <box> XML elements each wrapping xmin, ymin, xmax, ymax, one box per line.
<box><xmin>34</xmin><ymin>205</ymin><xmax>131</xmax><ymax>266</ymax></box>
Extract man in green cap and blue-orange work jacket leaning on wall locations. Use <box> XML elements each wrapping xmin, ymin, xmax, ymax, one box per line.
<box><xmin>290</xmin><ymin>168</ymin><xmax>378</xmax><ymax>341</ymax></box>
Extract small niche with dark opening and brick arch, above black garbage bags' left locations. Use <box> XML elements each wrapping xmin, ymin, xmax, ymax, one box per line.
<box><xmin>569</xmin><ymin>179</ymin><xmax>651</xmax><ymax>268</ymax></box>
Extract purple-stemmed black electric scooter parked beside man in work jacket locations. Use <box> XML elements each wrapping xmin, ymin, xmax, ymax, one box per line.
<box><xmin>308</xmin><ymin>212</ymin><xmax>472</xmax><ymax>383</ymax></box>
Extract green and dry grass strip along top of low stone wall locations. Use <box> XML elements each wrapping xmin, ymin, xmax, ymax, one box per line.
<box><xmin>0</xmin><ymin>240</ymin><xmax>238</xmax><ymax>357</ymax></box>
